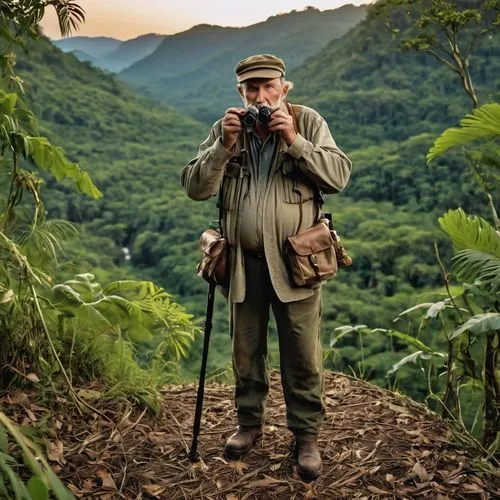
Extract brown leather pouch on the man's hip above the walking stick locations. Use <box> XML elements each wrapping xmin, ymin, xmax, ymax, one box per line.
<box><xmin>197</xmin><ymin>229</ymin><xmax>229</xmax><ymax>288</ymax></box>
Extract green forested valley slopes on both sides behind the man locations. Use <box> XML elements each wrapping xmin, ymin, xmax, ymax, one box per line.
<box><xmin>13</xmin><ymin>1</ymin><xmax>499</xmax><ymax>393</ymax></box>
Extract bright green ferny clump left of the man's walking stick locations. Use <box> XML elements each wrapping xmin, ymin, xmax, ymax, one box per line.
<box><xmin>43</xmin><ymin>274</ymin><xmax>195</xmax><ymax>412</ymax></box>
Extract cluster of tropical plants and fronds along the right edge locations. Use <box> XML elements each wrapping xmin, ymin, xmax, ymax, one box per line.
<box><xmin>331</xmin><ymin>95</ymin><xmax>500</xmax><ymax>456</ymax></box>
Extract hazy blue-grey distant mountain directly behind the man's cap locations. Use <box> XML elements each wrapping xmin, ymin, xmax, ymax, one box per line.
<box><xmin>120</xmin><ymin>5</ymin><xmax>365</xmax><ymax>123</ymax></box>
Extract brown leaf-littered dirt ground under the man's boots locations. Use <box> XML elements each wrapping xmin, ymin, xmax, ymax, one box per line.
<box><xmin>0</xmin><ymin>373</ymin><xmax>500</xmax><ymax>500</ymax></box>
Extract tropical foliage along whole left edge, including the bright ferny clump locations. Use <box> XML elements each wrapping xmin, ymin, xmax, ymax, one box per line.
<box><xmin>0</xmin><ymin>0</ymin><xmax>194</xmax><ymax>499</ymax></box>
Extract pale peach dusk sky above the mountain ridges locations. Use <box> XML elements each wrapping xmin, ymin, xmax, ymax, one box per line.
<box><xmin>42</xmin><ymin>0</ymin><xmax>370</xmax><ymax>40</ymax></box>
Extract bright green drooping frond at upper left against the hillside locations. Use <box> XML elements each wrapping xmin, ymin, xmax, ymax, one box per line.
<box><xmin>26</xmin><ymin>137</ymin><xmax>102</xmax><ymax>199</ymax></box>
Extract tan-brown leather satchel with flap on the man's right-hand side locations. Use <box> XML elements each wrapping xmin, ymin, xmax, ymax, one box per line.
<box><xmin>285</xmin><ymin>222</ymin><xmax>338</xmax><ymax>286</ymax></box>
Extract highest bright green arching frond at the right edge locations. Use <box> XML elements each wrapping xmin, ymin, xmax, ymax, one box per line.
<box><xmin>427</xmin><ymin>103</ymin><xmax>500</xmax><ymax>162</ymax></box>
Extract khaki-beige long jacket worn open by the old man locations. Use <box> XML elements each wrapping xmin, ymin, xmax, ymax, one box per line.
<box><xmin>181</xmin><ymin>105</ymin><xmax>351</xmax><ymax>302</ymax></box>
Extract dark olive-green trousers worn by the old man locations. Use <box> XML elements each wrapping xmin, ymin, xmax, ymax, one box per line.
<box><xmin>230</xmin><ymin>252</ymin><xmax>325</xmax><ymax>435</ymax></box>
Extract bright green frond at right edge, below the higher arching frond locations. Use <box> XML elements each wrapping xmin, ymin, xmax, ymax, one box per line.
<box><xmin>439</xmin><ymin>208</ymin><xmax>500</xmax><ymax>257</ymax></box>
